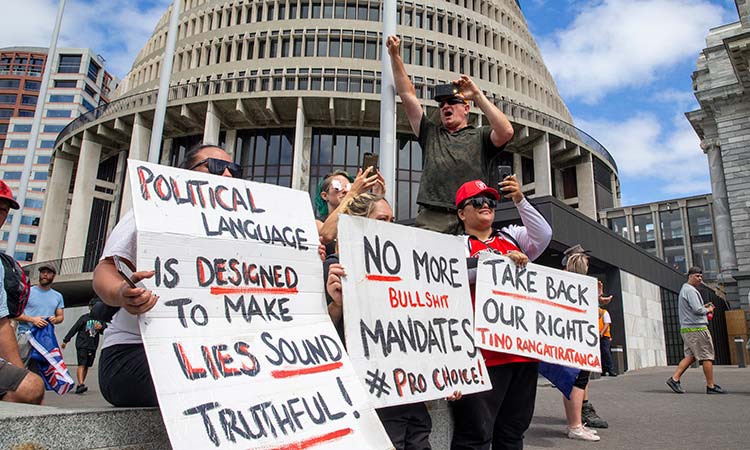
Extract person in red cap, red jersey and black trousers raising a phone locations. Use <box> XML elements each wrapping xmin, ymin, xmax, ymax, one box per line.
<box><xmin>450</xmin><ymin>175</ymin><xmax>552</xmax><ymax>450</ymax></box>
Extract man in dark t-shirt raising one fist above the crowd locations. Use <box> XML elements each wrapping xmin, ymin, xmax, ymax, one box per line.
<box><xmin>386</xmin><ymin>36</ymin><xmax>513</xmax><ymax>234</ymax></box>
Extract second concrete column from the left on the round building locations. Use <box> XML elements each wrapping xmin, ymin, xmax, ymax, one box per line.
<box><xmin>63</xmin><ymin>131</ymin><xmax>102</xmax><ymax>258</ymax></box>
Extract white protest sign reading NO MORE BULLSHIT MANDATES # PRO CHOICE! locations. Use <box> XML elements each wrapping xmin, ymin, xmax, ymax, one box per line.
<box><xmin>338</xmin><ymin>214</ymin><xmax>492</xmax><ymax>407</ymax></box>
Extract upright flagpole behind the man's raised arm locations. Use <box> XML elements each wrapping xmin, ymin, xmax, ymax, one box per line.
<box><xmin>380</xmin><ymin>0</ymin><xmax>396</xmax><ymax>210</ymax></box>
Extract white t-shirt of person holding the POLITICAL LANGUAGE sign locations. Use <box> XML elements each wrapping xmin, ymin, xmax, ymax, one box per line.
<box><xmin>101</xmin><ymin>210</ymin><xmax>143</xmax><ymax>348</ymax></box>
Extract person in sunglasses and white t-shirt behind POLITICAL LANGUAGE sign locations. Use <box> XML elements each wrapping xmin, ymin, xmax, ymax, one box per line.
<box><xmin>93</xmin><ymin>144</ymin><xmax>241</xmax><ymax>407</ymax></box>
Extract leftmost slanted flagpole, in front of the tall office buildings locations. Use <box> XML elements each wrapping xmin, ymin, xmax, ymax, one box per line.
<box><xmin>5</xmin><ymin>0</ymin><xmax>65</xmax><ymax>256</ymax></box>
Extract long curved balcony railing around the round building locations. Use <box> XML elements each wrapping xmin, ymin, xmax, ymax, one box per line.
<box><xmin>55</xmin><ymin>74</ymin><xmax>617</xmax><ymax>171</ymax></box>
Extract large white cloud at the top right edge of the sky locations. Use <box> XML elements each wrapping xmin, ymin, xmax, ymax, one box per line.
<box><xmin>540</xmin><ymin>0</ymin><xmax>736</xmax><ymax>103</ymax></box>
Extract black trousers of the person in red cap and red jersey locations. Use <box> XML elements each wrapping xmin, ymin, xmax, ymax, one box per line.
<box><xmin>448</xmin><ymin>362</ymin><xmax>539</xmax><ymax>450</ymax></box>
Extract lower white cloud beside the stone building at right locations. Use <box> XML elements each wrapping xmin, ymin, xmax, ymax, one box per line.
<box><xmin>576</xmin><ymin>108</ymin><xmax>711</xmax><ymax>198</ymax></box>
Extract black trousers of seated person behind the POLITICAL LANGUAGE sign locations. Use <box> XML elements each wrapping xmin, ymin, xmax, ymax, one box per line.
<box><xmin>99</xmin><ymin>344</ymin><xmax>159</xmax><ymax>407</ymax></box>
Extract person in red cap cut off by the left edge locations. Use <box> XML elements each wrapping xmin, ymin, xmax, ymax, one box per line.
<box><xmin>0</xmin><ymin>180</ymin><xmax>44</xmax><ymax>405</ymax></box>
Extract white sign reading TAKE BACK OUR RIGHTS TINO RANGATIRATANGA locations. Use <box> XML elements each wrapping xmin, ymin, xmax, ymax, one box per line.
<box><xmin>474</xmin><ymin>252</ymin><xmax>601</xmax><ymax>372</ymax></box>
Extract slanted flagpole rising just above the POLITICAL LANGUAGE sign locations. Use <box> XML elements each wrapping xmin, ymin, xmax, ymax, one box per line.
<box><xmin>148</xmin><ymin>0</ymin><xmax>183</xmax><ymax>164</ymax></box>
